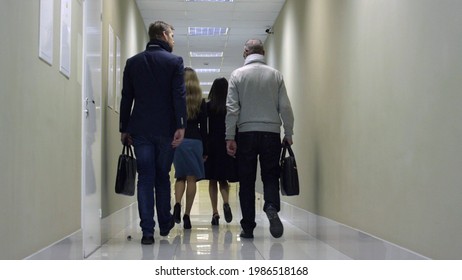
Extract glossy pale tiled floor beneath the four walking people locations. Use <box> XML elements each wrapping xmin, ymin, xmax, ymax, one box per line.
<box><xmin>88</xmin><ymin>182</ymin><xmax>350</xmax><ymax>260</ymax></box>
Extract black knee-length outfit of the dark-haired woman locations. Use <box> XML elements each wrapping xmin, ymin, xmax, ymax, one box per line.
<box><xmin>205</xmin><ymin>100</ymin><xmax>238</xmax><ymax>182</ymax></box>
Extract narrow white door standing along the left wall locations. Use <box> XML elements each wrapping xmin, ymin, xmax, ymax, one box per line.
<box><xmin>82</xmin><ymin>0</ymin><xmax>102</xmax><ymax>257</ymax></box>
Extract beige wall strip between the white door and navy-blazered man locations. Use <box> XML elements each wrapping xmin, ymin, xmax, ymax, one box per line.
<box><xmin>102</xmin><ymin>0</ymin><xmax>149</xmax><ymax>217</ymax></box>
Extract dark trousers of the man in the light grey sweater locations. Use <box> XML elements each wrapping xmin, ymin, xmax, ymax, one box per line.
<box><xmin>237</xmin><ymin>131</ymin><xmax>281</xmax><ymax>233</ymax></box>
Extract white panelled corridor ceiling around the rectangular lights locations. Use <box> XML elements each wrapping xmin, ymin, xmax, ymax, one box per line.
<box><xmin>136</xmin><ymin>0</ymin><xmax>285</xmax><ymax>94</ymax></box>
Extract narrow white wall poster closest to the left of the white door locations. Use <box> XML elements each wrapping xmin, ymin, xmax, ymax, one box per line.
<box><xmin>59</xmin><ymin>0</ymin><xmax>71</xmax><ymax>78</ymax></box>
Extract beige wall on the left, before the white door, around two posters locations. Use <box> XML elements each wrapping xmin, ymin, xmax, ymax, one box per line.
<box><xmin>0</xmin><ymin>0</ymin><xmax>82</xmax><ymax>259</ymax></box>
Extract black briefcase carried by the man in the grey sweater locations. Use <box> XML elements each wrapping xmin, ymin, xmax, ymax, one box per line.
<box><xmin>280</xmin><ymin>144</ymin><xmax>300</xmax><ymax>196</ymax></box>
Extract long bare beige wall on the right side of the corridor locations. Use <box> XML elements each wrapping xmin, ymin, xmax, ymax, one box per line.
<box><xmin>267</xmin><ymin>0</ymin><xmax>462</xmax><ymax>259</ymax></box>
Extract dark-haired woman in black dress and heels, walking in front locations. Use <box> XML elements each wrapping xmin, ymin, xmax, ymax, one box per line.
<box><xmin>205</xmin><ymin>78</ymin><xmax>238</xmax><ymax>225</ymax></box>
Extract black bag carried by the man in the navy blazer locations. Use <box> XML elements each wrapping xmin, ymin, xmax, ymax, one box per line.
<box><xmin>115</xmin><ymin>145</ymin><xmax>136</xmax><ymax>196</ymax></box>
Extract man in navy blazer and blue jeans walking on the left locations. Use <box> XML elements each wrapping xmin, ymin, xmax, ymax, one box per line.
<box><xmin>119</xmin><ymin>21</ymin><xmax>187</xmax><ymax>244</ymax></box>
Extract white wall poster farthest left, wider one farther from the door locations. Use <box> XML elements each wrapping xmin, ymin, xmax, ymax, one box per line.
<box><xmin>39</xmin><ymin>0</ymin><xmax>54</xmax><ymax>65</ymax></box>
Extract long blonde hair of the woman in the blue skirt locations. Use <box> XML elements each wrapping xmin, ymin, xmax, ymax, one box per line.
<box><xmin>184</xmin><ymin>67</ymin><xmax>202</xmax><ymax>120</ymax></box>
